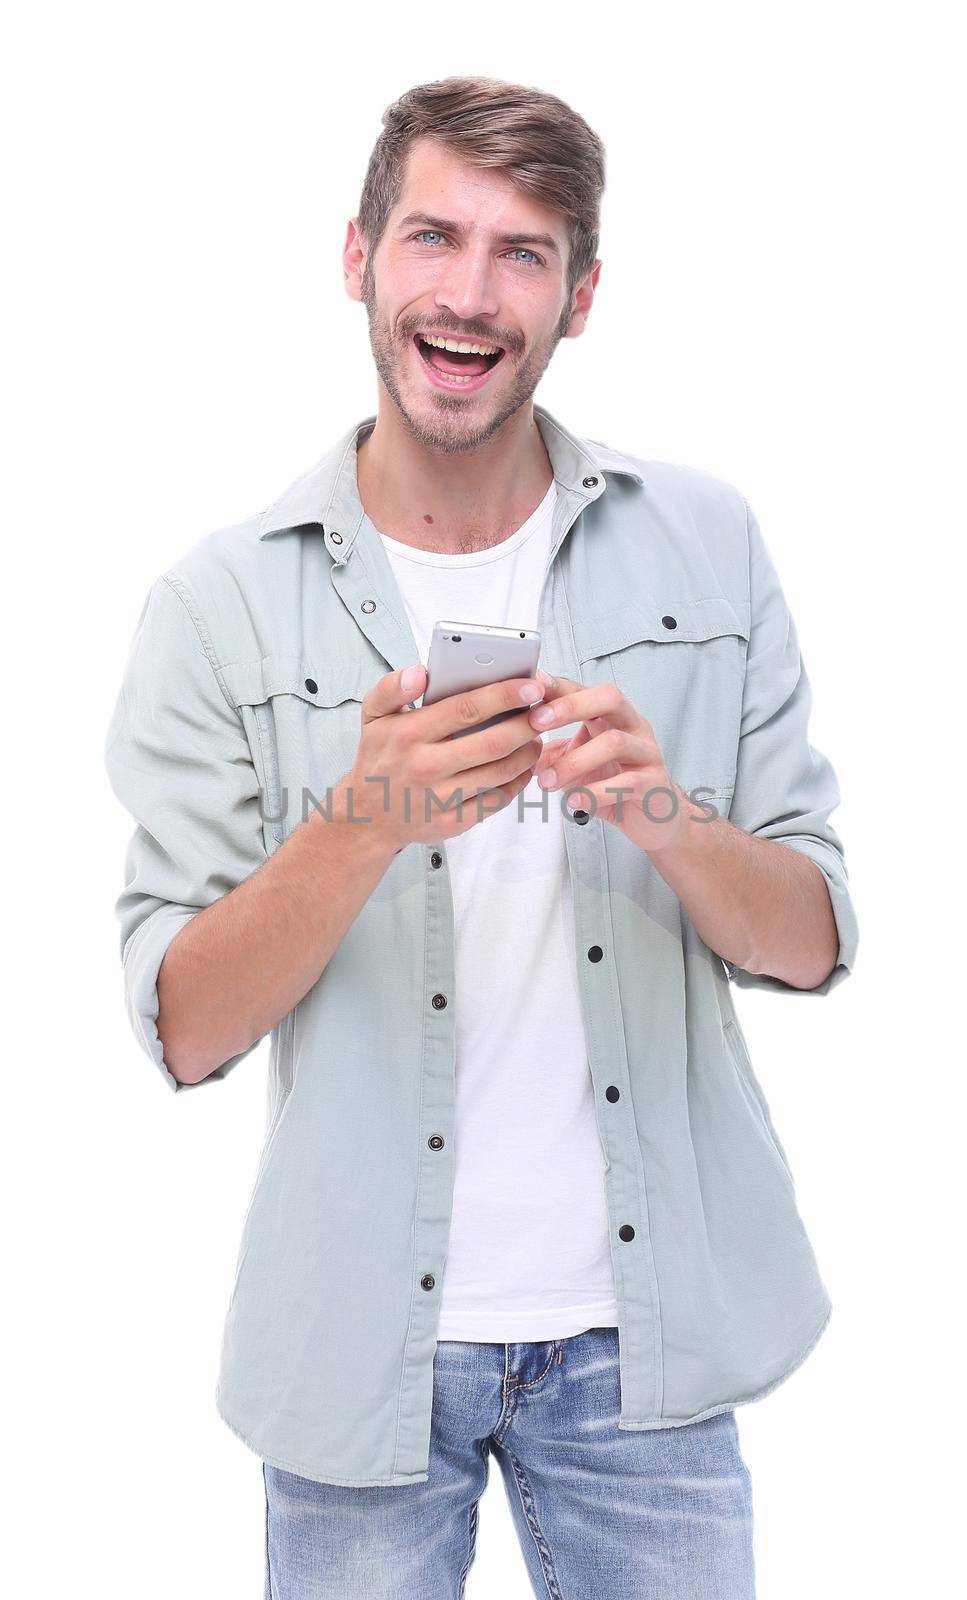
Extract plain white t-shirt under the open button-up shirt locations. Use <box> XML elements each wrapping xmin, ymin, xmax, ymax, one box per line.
<box><xmin>376</xmin><ymin>483</ymin><xmax>618</xmax><ymax>1342</ymax></box>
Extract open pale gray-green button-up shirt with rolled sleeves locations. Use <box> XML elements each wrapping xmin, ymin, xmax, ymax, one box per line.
<box><xmin>106</xmin><ymin>406</ymin><xmax>858</xmax><ymax>1485</ymax></box>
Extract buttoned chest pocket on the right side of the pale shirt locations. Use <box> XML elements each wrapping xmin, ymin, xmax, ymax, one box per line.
<box><xmin>575</xmin><ymin>595</ymin><xmax>749</xmax><ymax>814</ymax></box>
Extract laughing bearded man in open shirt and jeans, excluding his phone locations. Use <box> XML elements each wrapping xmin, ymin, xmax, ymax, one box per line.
<box><xmin>107</xmin><ymin>78</ymin><xmax>857</xmax><ymax>1600</ymax></box>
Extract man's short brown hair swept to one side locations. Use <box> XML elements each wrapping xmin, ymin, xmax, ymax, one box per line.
<box><xmin>359</xmin><ymin>78</ymin><xmax>605</xmax><ymax>307</ymax></box>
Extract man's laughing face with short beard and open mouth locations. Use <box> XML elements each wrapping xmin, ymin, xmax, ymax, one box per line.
<box><xmin>360</xmin><ymin>139</ymin><xmax>599</xmax><ymax>454</ymax></box>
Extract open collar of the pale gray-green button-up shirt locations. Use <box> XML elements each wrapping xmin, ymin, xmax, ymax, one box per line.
<box><xmin>258</xmin><ymin>403</ymin><xmax>644</xmax><ymax>562</ymax></box>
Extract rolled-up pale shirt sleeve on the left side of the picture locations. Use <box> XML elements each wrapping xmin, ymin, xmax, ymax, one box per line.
<box><xmin>104</xmin><ymin>574</ymin><xmax>266</xmax><ymax>1091</ymax></box>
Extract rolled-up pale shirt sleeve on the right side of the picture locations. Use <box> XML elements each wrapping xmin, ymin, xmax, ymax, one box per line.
<box><xmin>725</xmin><ymin>504</ymin><xmax>860</xmax><ymax>995</ymax></box>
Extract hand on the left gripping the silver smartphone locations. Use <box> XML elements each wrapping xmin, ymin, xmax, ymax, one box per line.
<box><xmin>335</xmin><ymin>666</ymin><xmax>544</xmax><ymax>851</ymax></box>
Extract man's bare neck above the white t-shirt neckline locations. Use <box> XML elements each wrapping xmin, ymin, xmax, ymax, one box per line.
<box><xmin>355</xmin><ymin>384</ymin><xmax>554</xmax><ymax>555</ymax></box>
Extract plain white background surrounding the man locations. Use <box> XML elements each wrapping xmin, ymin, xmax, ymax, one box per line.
<box><xmin>0</xmin><ymin>0</ymin><xmax>967</xmax><ymax>1600</ymax></box>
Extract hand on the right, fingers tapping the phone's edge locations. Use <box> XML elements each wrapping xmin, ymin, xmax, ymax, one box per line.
<box><xmin>530</xmin><ymin>672</ymin><xmax>694</xmax><ymax>853</ymax></box>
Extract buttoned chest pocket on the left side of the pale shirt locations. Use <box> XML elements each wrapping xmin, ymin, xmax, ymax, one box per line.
<box><xmin>223</xmin><ymin>656</ymin><xmax>371</xmax><ymax>851</ymax></box>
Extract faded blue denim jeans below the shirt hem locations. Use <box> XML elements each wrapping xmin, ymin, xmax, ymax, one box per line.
<box><xmin>263</xmin><ymin>1328</ymin><xmax>754</xmax><ymax>1600</ymax></box>
